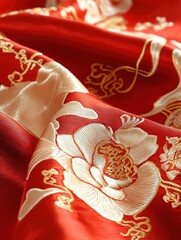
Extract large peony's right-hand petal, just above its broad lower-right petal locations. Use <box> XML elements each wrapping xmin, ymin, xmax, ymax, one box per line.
<box><xmin>130</xmin><ymin>135</ymin><xmax>158</xmax><ymax>164</ymax></box>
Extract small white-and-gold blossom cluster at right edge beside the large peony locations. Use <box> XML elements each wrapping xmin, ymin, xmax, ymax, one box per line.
<box><xmin>160</xmin><ymin>137</ymin><xmax>181</xmax><ymax>180</ymax></box>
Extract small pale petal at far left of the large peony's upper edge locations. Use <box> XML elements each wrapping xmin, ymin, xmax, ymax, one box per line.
<box><xmin>57</xmin><ymin>134</ymin><xmax>82</xmax><ymax>157</ymax></box>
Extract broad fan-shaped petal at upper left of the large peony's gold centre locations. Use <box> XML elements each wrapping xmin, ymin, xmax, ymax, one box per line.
<box><xmin>74</xmin><ymin>123</ymin><xmax>112</xmax><ymax>163</ymax></box>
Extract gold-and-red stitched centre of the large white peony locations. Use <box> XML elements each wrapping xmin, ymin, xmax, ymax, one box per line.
<box><xmin>98</xmin><ymin>142</ymin><xmax>137</xmax><ymax>181</ymax></box>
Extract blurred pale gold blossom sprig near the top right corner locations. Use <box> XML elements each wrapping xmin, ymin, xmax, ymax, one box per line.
<box><xmin>134</xmin><ymin>17</ymin><xmax>174</xmax><ymax>31</ymax></box>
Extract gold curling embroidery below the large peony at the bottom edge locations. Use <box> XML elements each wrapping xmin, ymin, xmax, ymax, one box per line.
<box><xmin>120</xmin><ymin>215</ymin><xmax>152</xmax><ymax>240</ymax></box>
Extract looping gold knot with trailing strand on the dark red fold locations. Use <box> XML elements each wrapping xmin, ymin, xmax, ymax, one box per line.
<box><xmin>85</xmin><ymin>39</ymin><xmax>151</xmax><ymax>98</ymax></box>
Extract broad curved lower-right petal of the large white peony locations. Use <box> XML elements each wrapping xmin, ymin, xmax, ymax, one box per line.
<box><xmin>116</xmin><ymin>162</ymin><xmax>160</xmax><ymax>215</ymax></box>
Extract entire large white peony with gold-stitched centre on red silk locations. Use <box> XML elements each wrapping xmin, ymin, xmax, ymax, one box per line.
<box><xmin>57</xmin><ymin>115</ymin><xmax>160</xmax><ymax>222</ymax></box>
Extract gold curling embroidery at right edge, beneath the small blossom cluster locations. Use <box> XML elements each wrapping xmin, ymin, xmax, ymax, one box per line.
<box><xmin>160</xmin><ymin>179</ymin><xmax>181</xmax><ymax>208</ymax></box>
